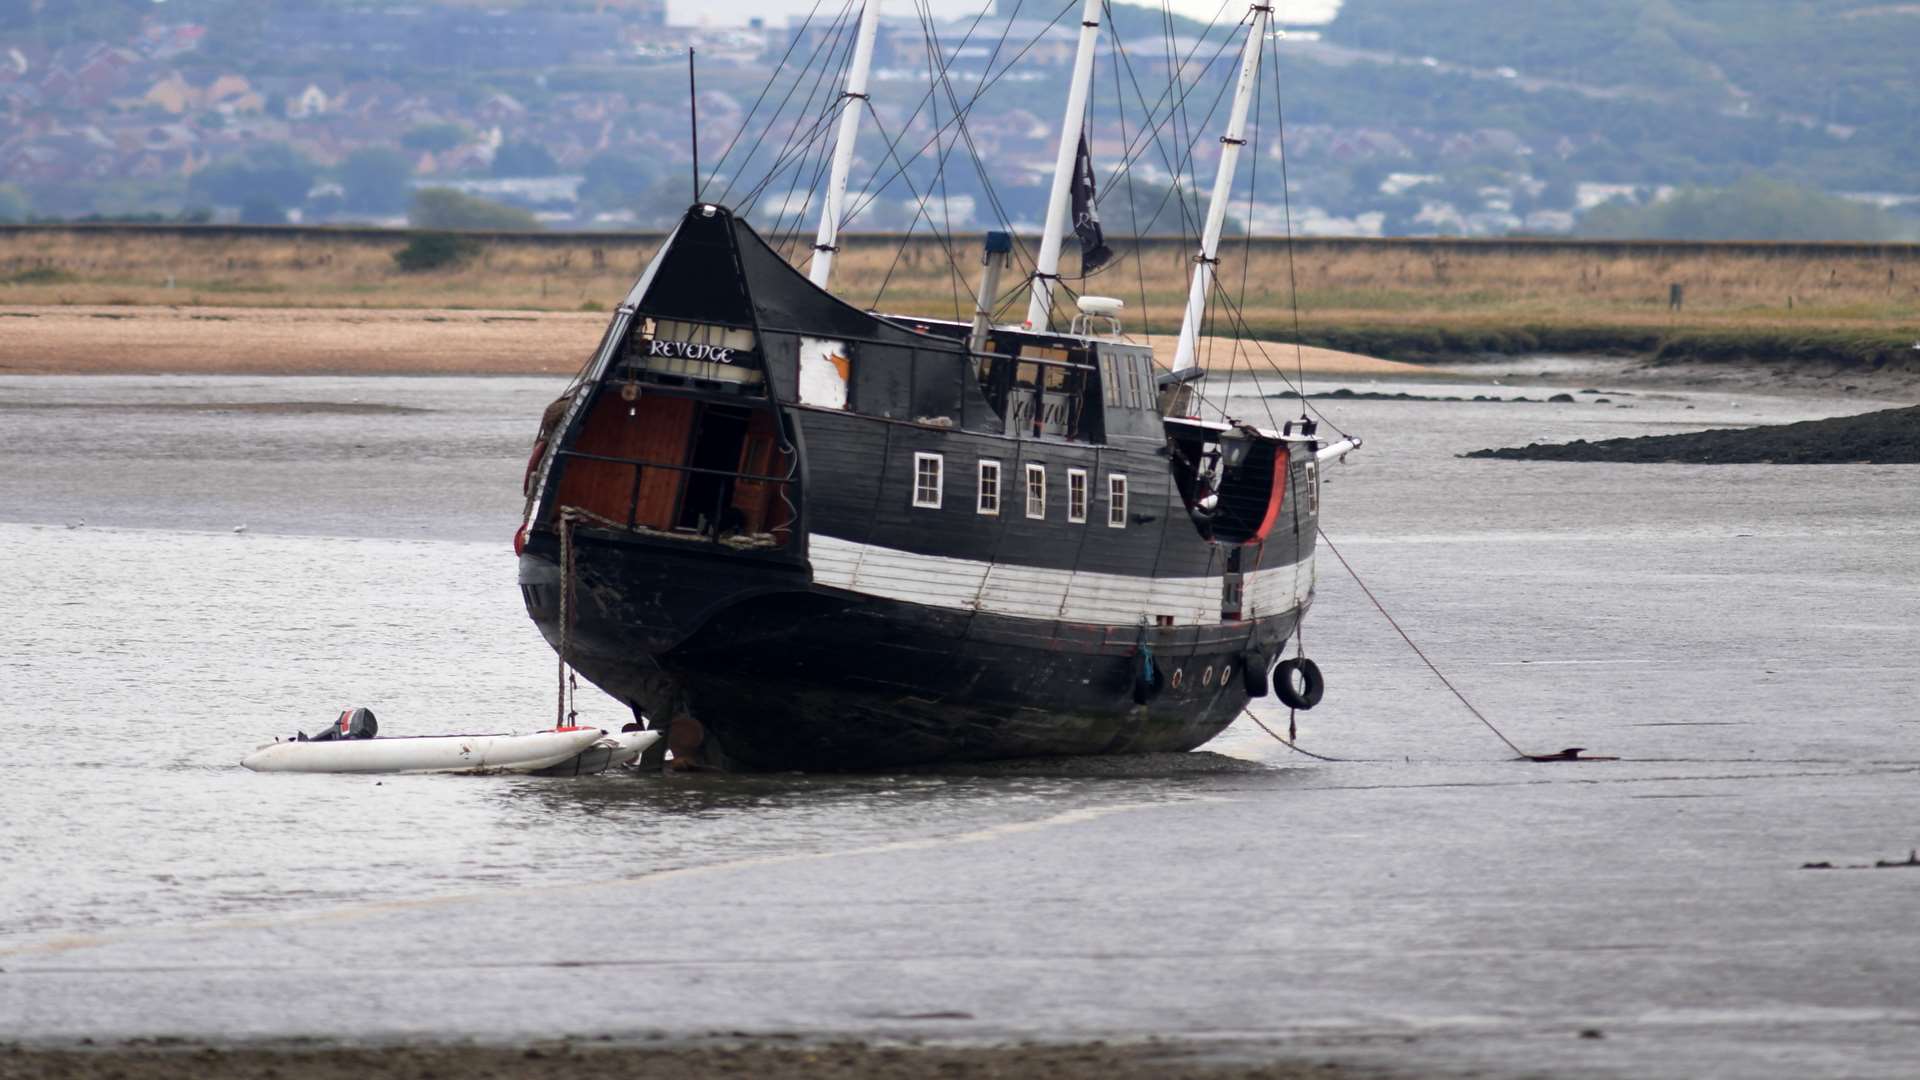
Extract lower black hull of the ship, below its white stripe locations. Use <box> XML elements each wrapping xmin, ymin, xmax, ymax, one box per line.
<box><xmin>522</xmin><ymin>530</ymin><xmax>1296</xmax><ymax>771</ymax></box>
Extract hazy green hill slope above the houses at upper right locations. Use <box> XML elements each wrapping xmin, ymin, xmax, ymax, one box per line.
<box><xmin>1327</xmin><ymin>0</ymin><xmax>1920</xmax><ymax>190</ymax></box>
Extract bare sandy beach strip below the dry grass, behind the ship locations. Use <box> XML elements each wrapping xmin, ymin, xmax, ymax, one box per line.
<box><xmin>0</xmin><ymin>306</ymin><xmax>1423</xmax><ymax>377</ymax></box>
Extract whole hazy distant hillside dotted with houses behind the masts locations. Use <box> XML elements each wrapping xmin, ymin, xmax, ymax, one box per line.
<box><xmin>11</xmin><ymin>0</ymin><xmax>1920</xmax><ymax>240</ymax></box>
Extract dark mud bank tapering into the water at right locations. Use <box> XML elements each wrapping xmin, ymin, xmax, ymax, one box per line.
<box><xmin>1461</xmin><ymin>405</ymin><xmax>1920</xmax><ymax>457</ymax></box>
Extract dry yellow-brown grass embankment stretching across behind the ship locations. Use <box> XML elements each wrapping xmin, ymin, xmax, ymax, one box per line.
<box><xmin>0</xmin><ymin>227</ymin><xmax>1920</xmax><ymax>367</ymax></box>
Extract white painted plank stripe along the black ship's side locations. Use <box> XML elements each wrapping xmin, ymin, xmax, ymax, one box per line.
<box><xmin>808</xmin><ymin>532</ymin><xmax>1313</xmax><ymax>626</ymax></box>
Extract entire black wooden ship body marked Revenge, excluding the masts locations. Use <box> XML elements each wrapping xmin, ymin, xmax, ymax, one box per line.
<box><xmin>520</xmin><ymin>206</ymin><xmax>1344</xmax><ymax>769</ymax></box>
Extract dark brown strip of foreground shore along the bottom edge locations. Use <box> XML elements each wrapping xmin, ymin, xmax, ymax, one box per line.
<box><xmin>0</xmin><ymin>1042</ymin><xmax>1388</xmax><ymax>1080</ymax></box>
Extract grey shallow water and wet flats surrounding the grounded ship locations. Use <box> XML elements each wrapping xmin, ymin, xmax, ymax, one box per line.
<box><xmin>0</xmin><ymin>365</ymin><xmax>1920</xmax><ymax>1076</ymax></box>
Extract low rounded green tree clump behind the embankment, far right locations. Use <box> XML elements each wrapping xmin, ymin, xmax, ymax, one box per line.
<box><xmin>1578</xmin><ymin>177</ymin><xmax>1916</xmax><ymax>240</ymax></box>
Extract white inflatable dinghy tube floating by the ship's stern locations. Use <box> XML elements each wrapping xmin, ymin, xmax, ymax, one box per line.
<box><xmin>240</xmin><ymin>726</ymin><xmax>614</xmax><ymax>773</ymax></box>
